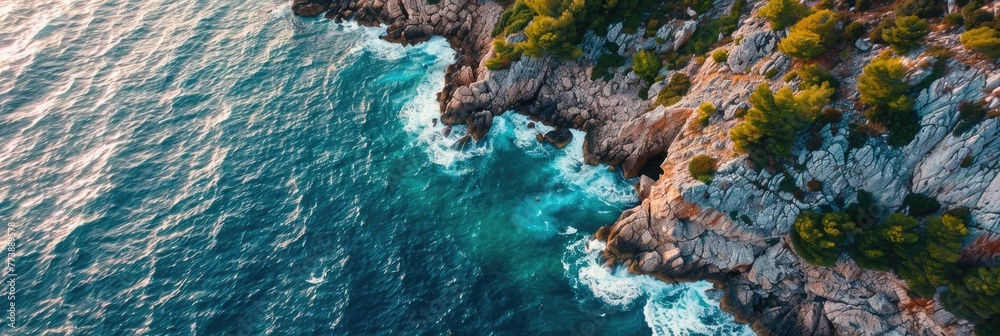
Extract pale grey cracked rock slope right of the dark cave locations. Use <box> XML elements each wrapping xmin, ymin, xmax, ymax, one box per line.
<box><xmin>604</xmin><ymin>20</ymin><xmax>1000</xmax><ymax>335</ymax></box>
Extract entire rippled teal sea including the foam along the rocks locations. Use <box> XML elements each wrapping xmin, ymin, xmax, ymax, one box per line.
<box><xmin>0</xmin><ymin>0</ymin><xmax>748</xmax><ymax>335</ymax></box>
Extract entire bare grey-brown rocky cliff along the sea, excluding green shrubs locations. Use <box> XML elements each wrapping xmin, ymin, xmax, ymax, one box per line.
<box><xmin>292</xmin><ymin>0</ymin><xmax>1000</xmax><ymax>335</ymax></box>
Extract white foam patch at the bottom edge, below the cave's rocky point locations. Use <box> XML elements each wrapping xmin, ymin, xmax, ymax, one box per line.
<box><xmin>563</xmin><ymin>238</ymin><xmax>753</xmax><ymax>336</ymax></box>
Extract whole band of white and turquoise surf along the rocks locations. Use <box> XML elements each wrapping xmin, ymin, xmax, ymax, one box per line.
<box><xmin>378</xmin><ymin>21</ymin><xmax>752</xmax><ymax>335</ymax></box>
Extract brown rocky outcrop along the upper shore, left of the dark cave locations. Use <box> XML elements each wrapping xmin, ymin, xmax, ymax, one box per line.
<box><xmin>292</xmin><ymin>0</ymin><xmax>712</xmax><ymax>177</ymax></box>
